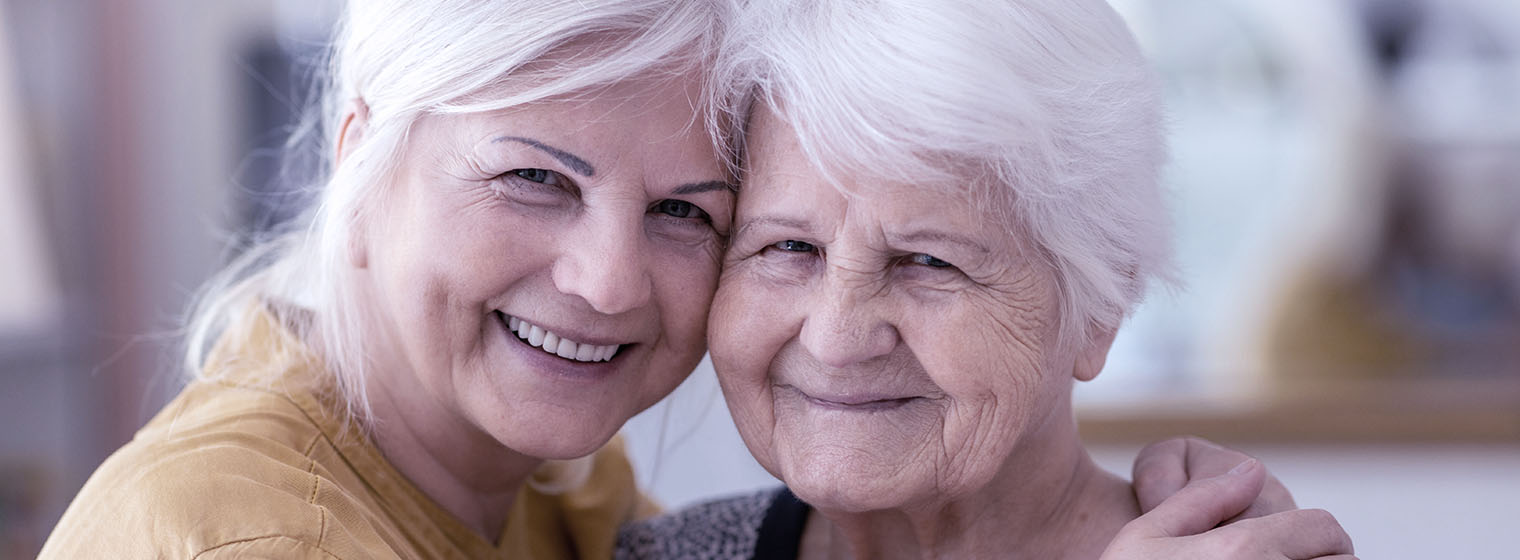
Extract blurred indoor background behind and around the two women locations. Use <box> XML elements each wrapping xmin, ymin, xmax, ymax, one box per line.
<box><xmin>0</xmin><ymin>0</ymin><xmax>1520</xmax><ymax>558</ymax></box>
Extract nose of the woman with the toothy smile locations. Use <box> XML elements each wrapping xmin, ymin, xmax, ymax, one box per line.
<box><xmin>553</xmin><ymin>211</ymin><xmax>654</xmax><ymax>315</ymax></box>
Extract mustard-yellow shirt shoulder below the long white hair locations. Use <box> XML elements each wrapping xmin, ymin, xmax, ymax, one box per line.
<box><xmin>43</xmin><ymin>382</ymin><xmax>376</xmax><ymax>558</ymax></box>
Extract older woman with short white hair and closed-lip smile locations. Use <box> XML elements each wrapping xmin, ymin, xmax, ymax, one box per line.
<box><xmin>620</xmin><ymin>0</ymin><xmax>1351</xmax><ymax>558</ymax></box>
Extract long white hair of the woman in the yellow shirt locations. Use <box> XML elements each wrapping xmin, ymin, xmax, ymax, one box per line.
<box><xmin>185</xmin><ymin>0</ymin><xmax>728</xmax><ymax>423</ymax></box>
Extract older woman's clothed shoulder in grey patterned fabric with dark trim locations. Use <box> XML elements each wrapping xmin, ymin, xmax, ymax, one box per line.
<box><xmin>617</xmin><ymin>488</ymin><xmax>784</xmax><ymax>560</ymax></box>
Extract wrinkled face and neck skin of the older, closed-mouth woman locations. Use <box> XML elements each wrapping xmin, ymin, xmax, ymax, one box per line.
<box><xmin>711</xmin><ymin>107</ymin><xmax>1132</xmax><ymax>557</ymax></box>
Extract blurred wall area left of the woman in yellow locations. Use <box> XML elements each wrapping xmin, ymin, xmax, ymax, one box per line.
<box><xmin>0</xmin><ymin>0</ymin><xmax>330</xmax><ymax>557</ymax></box>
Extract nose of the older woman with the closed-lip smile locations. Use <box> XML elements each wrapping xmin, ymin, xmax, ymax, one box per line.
<box><xmin>800</xmin><ymin>270</ymin><xmax>898</xmax><ymax>368</ymax></box>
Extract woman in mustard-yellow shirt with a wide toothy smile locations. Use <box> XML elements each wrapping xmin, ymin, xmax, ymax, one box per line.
<box><xmin>43</xmin><ymin>0</ymin><xmax>1313</xmax><ymax>558</ymax></box>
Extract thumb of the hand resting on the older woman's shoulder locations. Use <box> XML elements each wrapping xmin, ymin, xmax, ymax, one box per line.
<box><xmin>1129</xmin><ymin>460</ymin><xmax>1266</xmax><ymax>537</ymax></box>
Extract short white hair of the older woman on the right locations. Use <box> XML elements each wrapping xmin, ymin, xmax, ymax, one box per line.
<box><xmin>714</xmin><ymin>0</ymin><xmax>1170</xmax><ymax>342</ymax></box>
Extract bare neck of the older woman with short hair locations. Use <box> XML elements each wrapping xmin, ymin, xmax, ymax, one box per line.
<box><xmin>803</xmin><ymin>406</ymin><xmax>1140</xmax><ymax>558</ymax></box>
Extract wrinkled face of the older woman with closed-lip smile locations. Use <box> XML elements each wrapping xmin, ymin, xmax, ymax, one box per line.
<box><xmin>710</xmin><ymin>109</ymin><xmax>1073</xmax><ymax>511</ymax></box>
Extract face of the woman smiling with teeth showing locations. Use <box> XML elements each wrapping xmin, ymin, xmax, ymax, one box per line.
<box><xmin>359</xmin><ymin>76</ymin><xmax>733</xmax><ymax>458</ymax></box>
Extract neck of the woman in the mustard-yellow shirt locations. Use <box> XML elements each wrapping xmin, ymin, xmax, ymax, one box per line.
<box><xmin>366</xmin><ymin>360</ymin><xmax>543</xmax><ymax>542</ymax></box>
